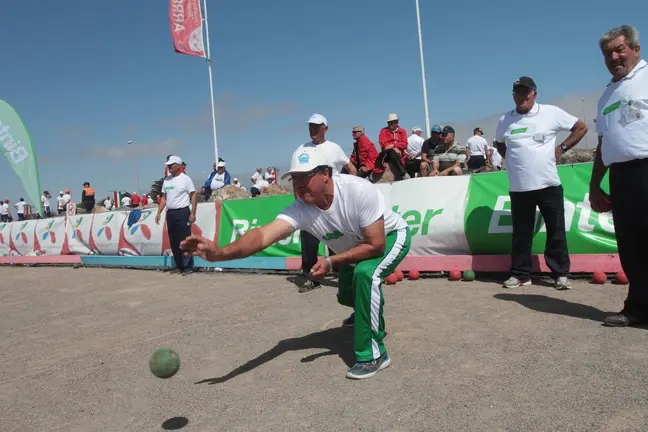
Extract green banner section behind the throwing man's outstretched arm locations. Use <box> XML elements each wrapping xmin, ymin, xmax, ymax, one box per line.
<box><xmin>218</xmin><ymin>195</ymin><xmax>324</xmax><ymax>258</ymax></box>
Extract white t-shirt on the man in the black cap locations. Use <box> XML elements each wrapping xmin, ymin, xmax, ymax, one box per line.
<box><xmin>495</xmin><ymin>103</ymin><xmax>578</xmax><ymax>192</ymax></box>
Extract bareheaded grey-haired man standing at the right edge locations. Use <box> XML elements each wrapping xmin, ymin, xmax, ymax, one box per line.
<box><xmin>589</xmin><ymin>25</ymin><xmax>648</xmax><ymax>327</ymax></box>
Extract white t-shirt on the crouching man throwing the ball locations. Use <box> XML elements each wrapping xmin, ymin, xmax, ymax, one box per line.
<box><xmin>277</xmin><ymin>174</ymin><xmax>407</xmax><ymax>254</ymax></box>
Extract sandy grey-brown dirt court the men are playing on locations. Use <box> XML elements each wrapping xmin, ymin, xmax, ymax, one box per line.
<box><xmin>0</xmin><ymin>267</ymin><xmax>648</xmax><ymax>432</ymax></box>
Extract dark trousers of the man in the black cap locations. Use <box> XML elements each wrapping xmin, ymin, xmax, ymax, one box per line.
<box><xmin>510</xmin><ymin>186</ymin><xmax>571</xmax><ymax>280</ymax></box>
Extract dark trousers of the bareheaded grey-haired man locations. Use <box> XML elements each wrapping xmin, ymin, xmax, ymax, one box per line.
<box><xmin>610</xmin><ymin>159</ymin><xmax>648</xmax><ymax>319</ymax></box>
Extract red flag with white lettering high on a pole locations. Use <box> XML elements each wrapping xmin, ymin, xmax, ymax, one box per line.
<box><xmin>169</xmin><ymin>0</ymin><xmax>205</xmax><ymax>57</ymax></box>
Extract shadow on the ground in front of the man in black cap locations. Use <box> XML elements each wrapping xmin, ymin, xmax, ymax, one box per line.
<box><xmin>493</xmin><ymin>294</ymin><xmax>615</xmax><ymax>322</ymax></box>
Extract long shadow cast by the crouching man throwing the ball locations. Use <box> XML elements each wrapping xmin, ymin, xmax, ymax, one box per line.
<box><xmin>196</xmin><ymin>327</ymin><xmax>355</xmax><ymax>384</ymax></box>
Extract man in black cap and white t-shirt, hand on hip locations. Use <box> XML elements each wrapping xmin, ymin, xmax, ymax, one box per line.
<box><xmin>495</xmin><ymin>77</ymin><xmax>587</xmax><ymax>290</ymax></box>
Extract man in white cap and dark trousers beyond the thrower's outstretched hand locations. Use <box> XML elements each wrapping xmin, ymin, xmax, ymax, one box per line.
<box><xmin>155</xmin><ymin>156</ymin><xmax>198</xmax><ymax>276</ymax></box>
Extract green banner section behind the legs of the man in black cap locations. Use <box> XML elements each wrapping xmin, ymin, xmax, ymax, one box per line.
<box><xmin>464</xmin><ymin>163</ymin><xmax>617</xmax><ymax>255</ymax></box>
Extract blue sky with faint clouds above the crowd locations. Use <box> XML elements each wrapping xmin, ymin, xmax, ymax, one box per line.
<box><xmin>0</xmin><ymin>0</ymin><xmax>648</xmax><ymax>202</ymax></box>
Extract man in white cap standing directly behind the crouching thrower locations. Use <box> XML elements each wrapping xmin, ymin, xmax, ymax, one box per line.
<box><xmin>296</xmin><ymin>114</ymin><xmax>358</xmax><ymax>293</ymax></box>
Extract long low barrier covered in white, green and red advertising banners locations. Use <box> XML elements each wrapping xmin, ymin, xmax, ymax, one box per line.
<box><xmin>0</xmin><ymin>163</ymin><xmax>620</xmax><ymax>272</ymax></box>
